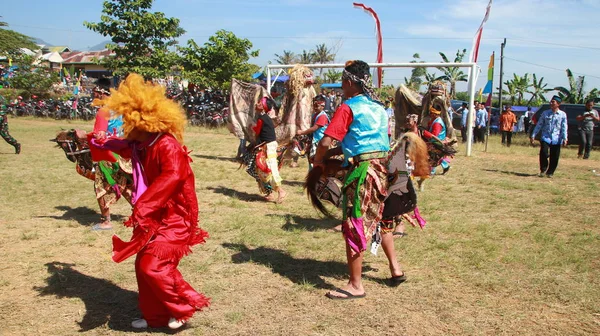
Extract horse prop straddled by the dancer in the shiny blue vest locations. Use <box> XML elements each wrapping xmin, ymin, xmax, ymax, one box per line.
<box><xmin>304</xmin><ymin>132</ymin><xmax>429</xmax><ymax>228</ymax></box>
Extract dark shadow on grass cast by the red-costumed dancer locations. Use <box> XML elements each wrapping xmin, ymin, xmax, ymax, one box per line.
<box><xmin>34</xmin><ymin>261</ymin><xmax>186</xmax><ymax>334</ymax></box>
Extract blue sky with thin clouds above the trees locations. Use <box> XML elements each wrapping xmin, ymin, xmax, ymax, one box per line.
<box><xmin>0</xmin><ymin>0</ymin><xmax>600</xmax><ymax>97</ymax></box>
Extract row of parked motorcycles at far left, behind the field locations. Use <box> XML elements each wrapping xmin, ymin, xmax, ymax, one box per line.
<box><xmin>3</xmin><ymin>96</ymin><xmax>96</xmax><ymax>120</ymax></box>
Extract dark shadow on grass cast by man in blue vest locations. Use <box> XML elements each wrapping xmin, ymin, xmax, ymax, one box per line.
<box><xmin>223</xmin><ymin>243</ymin><xmax>358</xmax><ymax>289</ymax></box>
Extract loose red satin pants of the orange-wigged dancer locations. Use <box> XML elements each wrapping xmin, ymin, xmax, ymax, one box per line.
<box><xmin>135</xmin><ymin>249</ymin><xmax>209</xmax><ymax>328</ymax></box>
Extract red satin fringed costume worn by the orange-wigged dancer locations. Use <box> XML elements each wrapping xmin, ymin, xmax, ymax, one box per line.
<box><xmin>113</xmin><ymin>134</ymin><xmax>209</xmax><ymax>327</ymax></box>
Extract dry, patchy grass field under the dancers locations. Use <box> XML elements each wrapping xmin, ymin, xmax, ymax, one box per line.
<box><xmin>0</xmin><ymin>118</ymin><xmax>600</xmax><ymax>335</ymax></box>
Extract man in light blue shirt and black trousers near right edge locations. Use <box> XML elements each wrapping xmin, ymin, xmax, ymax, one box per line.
<box><xmin>529</xmin><ymin>96</ymin><xmax>568</xmax><ymax>178</ymax></box>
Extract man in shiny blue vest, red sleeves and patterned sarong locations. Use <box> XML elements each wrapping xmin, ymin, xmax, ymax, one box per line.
<box><xmin>313</xmin><ymin>60</ymin><xmax>406</xmax><ymax>300</ymax></box>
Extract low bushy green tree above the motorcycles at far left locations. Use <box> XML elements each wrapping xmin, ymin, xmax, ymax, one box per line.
<box><xmin>8</xmin><ymin>55</ymin><xmax>60</xmax><ymax>97</ymax></box>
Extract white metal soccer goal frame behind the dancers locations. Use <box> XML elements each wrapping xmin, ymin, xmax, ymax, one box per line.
<box><xmin>267</xmin><ymin>63</ymin><xmax>479</xmax><ymax>156</ymax></box>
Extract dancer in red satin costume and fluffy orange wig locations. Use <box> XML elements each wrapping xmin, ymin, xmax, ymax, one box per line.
<box><xmin>92</xmin><ymin>74</ymin><xmax>209</xmax><ymax>329</ymax></box>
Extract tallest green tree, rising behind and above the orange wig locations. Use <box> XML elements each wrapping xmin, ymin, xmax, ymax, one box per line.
<box><xmin>83</xmin><ymin>0</ymin><xmax>185</xmax><ymax>78</ymax></box>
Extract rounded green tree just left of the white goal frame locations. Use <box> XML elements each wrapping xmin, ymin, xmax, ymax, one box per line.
<box><xmin>179</xmin><ymin>29</ymin><xmax>260</xmax><ymax>89</ymax></box>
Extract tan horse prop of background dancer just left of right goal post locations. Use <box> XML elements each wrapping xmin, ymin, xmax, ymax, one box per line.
<box><xmin>394</xmin><ymin>81</ymin><xmax>457</xmax><ymax>191</ymax></box>
